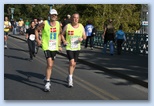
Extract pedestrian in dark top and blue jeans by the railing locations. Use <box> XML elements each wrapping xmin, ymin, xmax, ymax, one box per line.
<box><xmin>102</xmin><ymin>19</ymin><xmax>115</xmax><ymax>55</ymax></box>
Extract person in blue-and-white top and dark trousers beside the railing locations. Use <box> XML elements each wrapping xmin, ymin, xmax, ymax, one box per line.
<box><xmin>85</xmin><ymin>20</ymin><xmax>94</xmax><ymax>50</ymax></box>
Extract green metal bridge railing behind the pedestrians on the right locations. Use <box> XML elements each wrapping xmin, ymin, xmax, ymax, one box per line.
<box><xmin>83</xmin><ymin>31</ymin><xmax>148</xmax><ymax>55</ymax></box>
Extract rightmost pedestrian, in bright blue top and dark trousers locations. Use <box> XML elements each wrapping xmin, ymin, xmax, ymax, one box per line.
<box><xmin>115</xmin><ymin>25</ymin><xmax>126</xmax><ymax>55</ymax></box>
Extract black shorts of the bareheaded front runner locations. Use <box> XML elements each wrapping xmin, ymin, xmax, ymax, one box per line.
<box><xmin>66</xmin><ymin>50</ymin><xmax>80</xmax><ymax>62</ymax></box>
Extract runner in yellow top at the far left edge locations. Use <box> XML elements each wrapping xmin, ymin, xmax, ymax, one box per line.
<box><xmin>4</xmin><ymin>17</ymin><xmax>11</xmax><ymax>49</ymax></box>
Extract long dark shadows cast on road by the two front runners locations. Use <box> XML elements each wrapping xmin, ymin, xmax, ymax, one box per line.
<box><xmin>4</xmin><ymin>70</ymin><xmax>68</xmax><ymax>91</ymax></box>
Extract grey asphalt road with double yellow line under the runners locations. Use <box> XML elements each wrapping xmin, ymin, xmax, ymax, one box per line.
<box><xmin>4</xmin><ymin>37</ymin><xmax>148</xmax><ymax>100</ymax></box>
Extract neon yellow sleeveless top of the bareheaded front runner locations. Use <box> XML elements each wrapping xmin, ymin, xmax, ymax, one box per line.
<box><xmin>66</xmin><ymin>23</ymin><xmax>84</xmax><ymax>51</ymax></box>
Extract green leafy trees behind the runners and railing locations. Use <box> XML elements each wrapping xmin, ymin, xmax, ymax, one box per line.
<box><xmin>4</xmin><ymin>4</ymin><xmax>141</xmax><ymax>32</ymax></box>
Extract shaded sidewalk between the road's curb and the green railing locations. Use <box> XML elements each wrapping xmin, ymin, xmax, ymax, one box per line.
<box><xmin>8</xmin><ymin>34</ymin><xmax>148</xmax><ymax>88</ymax></box>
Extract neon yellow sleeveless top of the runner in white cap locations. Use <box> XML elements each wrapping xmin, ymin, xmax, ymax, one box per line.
<box><xmin>42</xmin><ymin>20</ymin><xmax>60</xmax><ymax>51</ymax></box>
